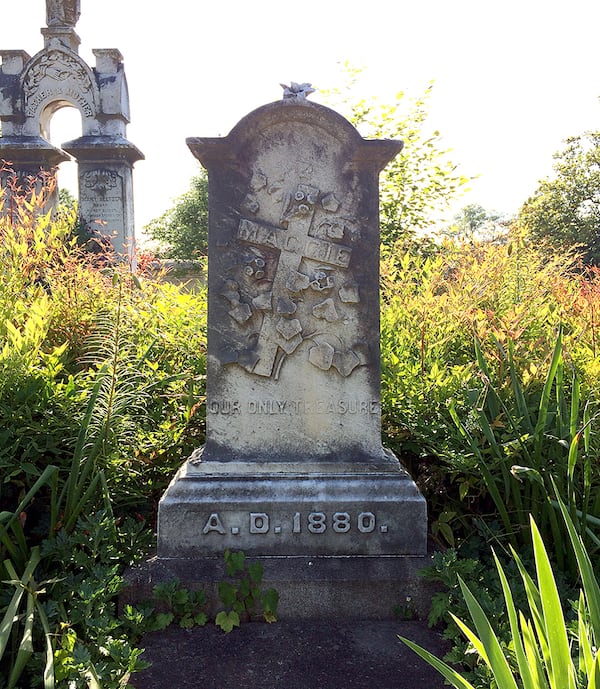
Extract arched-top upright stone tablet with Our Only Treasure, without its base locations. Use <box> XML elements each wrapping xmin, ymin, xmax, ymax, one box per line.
<box><xmin>189</xmin><ymin>99</ymin><xmax>400</xmax><ymax>462</ymax></box>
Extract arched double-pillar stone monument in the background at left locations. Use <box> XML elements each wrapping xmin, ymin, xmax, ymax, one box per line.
<box><xmin>0</xmin><ymin>0</ymin><xmax>144</xmax><ymax>254</ymax></box>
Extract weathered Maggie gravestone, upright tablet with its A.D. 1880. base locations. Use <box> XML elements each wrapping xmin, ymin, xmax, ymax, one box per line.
<box><xmin>158</xmin><ymin>84</ymin><xmax>427</xmax><ymax>564</ymax></box>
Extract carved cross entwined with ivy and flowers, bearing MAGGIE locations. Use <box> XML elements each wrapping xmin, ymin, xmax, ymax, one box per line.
<box><xmin>221</xmin><ymin>170</ymin><xmax>367</xmax><ymax>379</ymax></box>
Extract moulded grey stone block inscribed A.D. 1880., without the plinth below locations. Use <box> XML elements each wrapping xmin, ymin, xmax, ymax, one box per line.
<box><xmin>158</xmin><ymin>453</ymin><xmax>427</xmax><ymax>558</ymax></box>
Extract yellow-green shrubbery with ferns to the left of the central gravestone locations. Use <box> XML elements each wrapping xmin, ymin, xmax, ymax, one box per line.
<box><xmin>0</xmin><ymin>173</ymin><xmax>205</xmax><ymax>689</ymax></box>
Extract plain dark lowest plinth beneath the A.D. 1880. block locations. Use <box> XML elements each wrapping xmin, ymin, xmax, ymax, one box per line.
<box><xmin>121</xmin><ymin>554</ymin><xmax>437</xmax><ymax>620</ymax></box>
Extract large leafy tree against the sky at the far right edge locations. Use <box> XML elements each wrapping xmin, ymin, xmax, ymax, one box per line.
<box><xmin>518</xmin><ymin>131</ymin><xmax>600</xmax><ymax>265</ymax></box>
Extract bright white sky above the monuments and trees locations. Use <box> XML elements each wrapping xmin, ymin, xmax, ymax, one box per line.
<box><xmin>0</xmin><ymin>0</ymin><xmax>600</xmax><ymax>239</ymax></box>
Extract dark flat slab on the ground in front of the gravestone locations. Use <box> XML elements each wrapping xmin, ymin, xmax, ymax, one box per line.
<box><xmin>131</xmin><ymin>619</ymin><xmax>445</xmax><ymax>689</ymax></box>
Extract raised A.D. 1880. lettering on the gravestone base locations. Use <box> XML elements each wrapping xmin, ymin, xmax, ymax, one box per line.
<box><xmin>202</xmin><ymin>511</ymin><xmax>389</xmax><ymax>536</ymax></box>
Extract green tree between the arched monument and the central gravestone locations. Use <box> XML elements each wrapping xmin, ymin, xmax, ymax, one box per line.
<box><xmin>144</xmin><ymin>169</ymin><xmax>208</xmax><ymax>259</ymax></box>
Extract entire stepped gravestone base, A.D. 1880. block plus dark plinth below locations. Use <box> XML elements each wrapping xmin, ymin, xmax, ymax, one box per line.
<box><xmin>130</xmin><ymin>446</ymin><xmax>431</xmax><ymax>619</ymax></box>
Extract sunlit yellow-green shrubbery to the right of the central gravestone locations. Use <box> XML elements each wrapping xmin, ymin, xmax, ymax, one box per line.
<box><xmin>381</xmin><ymin>232</ymin><xmax>600</xmax><ymax>552</ymax></box>
